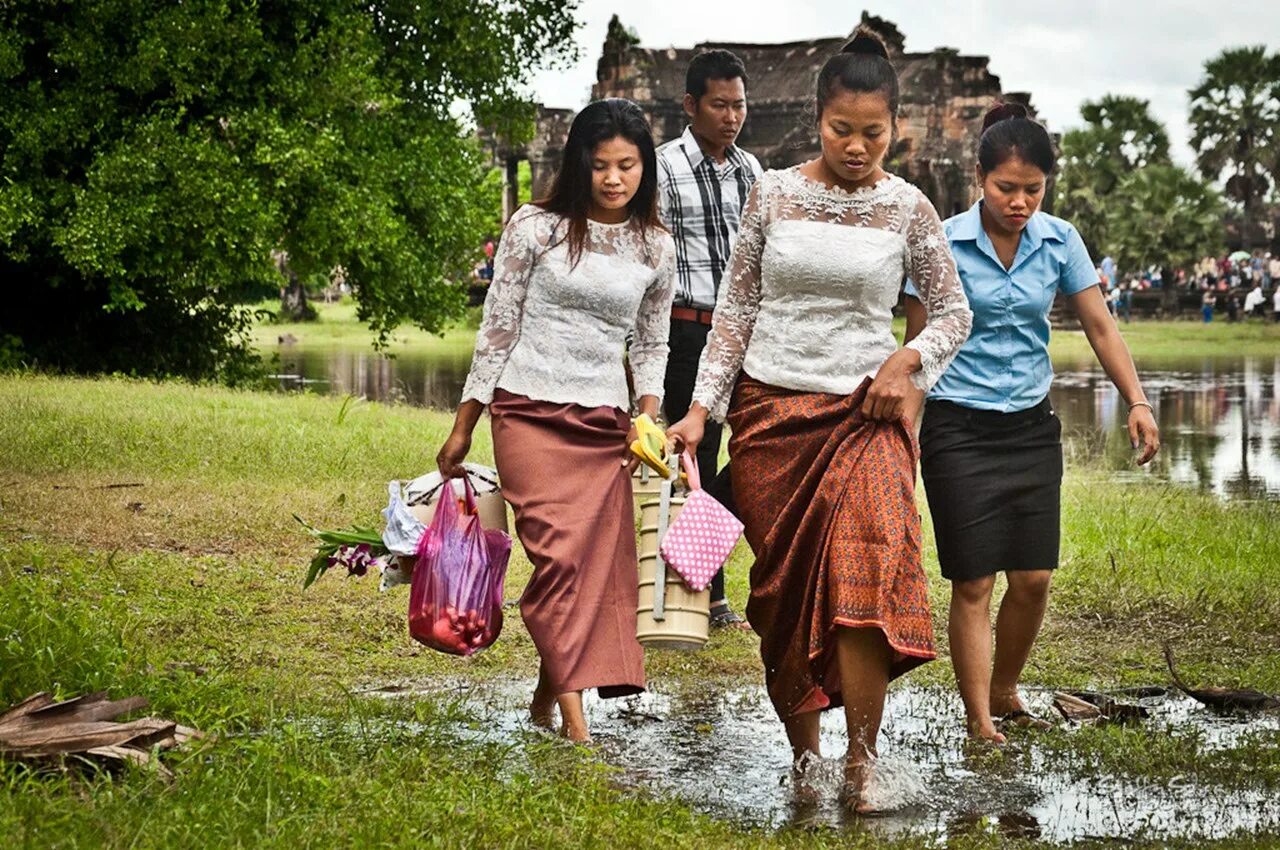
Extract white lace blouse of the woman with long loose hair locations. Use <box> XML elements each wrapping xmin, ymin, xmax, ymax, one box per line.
<box><xmin>462</xmin><ymin>204</ymin><xmax>676</xmax><ymax>410</ymax></box>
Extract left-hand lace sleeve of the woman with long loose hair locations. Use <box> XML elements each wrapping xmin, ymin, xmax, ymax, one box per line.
<box><xmin>462</xmin><ymin>205</ymin><xmax>538</xmax><ymax>405</ymax></box>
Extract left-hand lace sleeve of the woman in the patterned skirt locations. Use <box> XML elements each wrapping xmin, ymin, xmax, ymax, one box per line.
<box><xmin>692</xmin><ymin>177</ymin><xmax>768</xmax><ymax>421</ymax></box>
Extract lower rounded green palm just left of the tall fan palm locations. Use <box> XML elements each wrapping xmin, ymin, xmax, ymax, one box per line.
<box><xmin>1106</xmin><ymin>165</ymin><xmax>1225</xmax><ymax>307</ymax></box>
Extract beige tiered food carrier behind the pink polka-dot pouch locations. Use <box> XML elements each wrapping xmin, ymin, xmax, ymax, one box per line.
<box><xmin>636</xmin><ymin>458</ymin><xmax>712</xmax><ymax>649</ymax></box>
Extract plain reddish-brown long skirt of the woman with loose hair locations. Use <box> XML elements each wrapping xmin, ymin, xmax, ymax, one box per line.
<box><xmin>489</xmin><ymin>389</ymin><xmax>645</xmax><ymax>698</ymax></box>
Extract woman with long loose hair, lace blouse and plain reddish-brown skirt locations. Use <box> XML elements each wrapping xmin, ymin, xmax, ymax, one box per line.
<box><xmin>436</xmin><ymin>99</ymin><xmax>675</xmax><ymax>741</ymax></box>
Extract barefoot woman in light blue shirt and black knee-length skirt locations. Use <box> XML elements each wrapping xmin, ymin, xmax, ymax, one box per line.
<box><xmin>908</xmin><ymin>104</ymin><xmax>1160</xmax><ymax>742</ymax></box>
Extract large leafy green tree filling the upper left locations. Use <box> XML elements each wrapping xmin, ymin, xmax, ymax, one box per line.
<box><xmin>0</xmin><ymin>0</ymin><xmax>576</xmax><ymax>379</ymax></box>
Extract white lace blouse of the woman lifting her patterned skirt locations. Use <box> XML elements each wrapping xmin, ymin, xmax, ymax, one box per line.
<box><xmin>694</xmin><ymin>166</ymin><xmax>973</xmax><ymax>420</ymax></box>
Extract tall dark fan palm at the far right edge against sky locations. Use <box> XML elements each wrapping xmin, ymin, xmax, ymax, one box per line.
<box><xmin>1188</xmin><ymin>45</ymin><xmax>1280</xmax><ymax>247</ymax></box>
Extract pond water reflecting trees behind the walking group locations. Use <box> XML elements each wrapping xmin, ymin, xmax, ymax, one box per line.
<box><xmin>269</xmin><ymin>346</ymin><xmax>1280</xmax><ymax>501</ymax></box>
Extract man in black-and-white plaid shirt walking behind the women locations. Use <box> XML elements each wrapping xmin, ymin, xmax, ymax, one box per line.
<box><xmin>658</xmin><ymin>50</ymin><xmax>760</xmax><ymax>627</ymax></box>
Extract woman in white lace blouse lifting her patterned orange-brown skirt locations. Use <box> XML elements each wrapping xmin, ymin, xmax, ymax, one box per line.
<box><xmin>668</xmin><ymin>32</ymin><xmax>972</xmax><ymax>812</ymax></box>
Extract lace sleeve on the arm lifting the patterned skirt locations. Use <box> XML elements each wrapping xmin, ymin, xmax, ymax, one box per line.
<box><xmin>906</xmin><ymin>193</ymin><xmax>973</xmax><ymax>389</ymax></box>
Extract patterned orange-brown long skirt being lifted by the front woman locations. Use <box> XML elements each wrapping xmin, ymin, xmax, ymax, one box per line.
<box><xmin>728</xmin><ymin>375</ymin><xmax>936</xmax><ymax>719</ymax></box>
